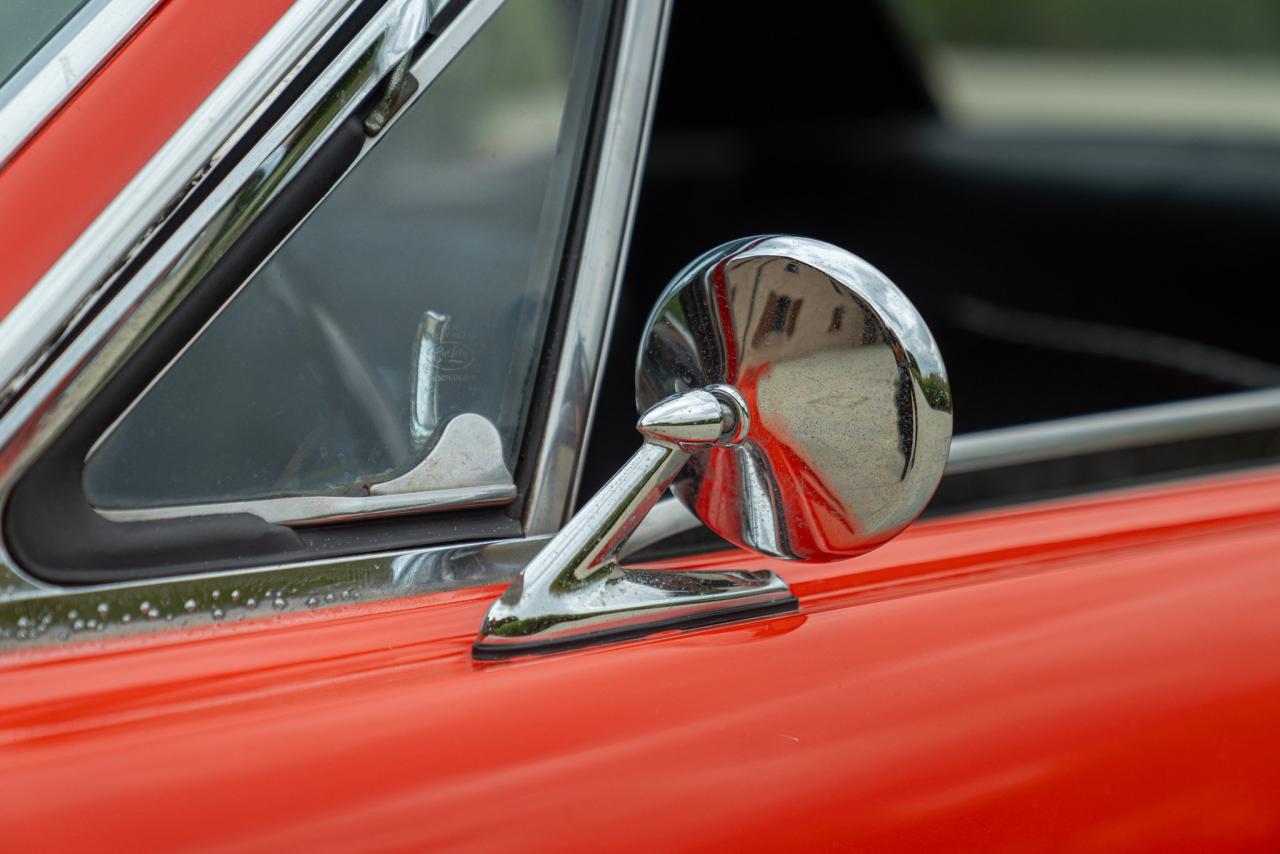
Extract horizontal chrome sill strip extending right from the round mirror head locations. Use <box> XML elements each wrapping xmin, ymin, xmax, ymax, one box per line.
<box><xmin>946</xmin><ymin>388</ymin><xmax>1280</xmax><ymax>475</ymax></box>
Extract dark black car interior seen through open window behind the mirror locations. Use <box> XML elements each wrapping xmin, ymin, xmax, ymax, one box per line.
<box><xmin>581</xmin><ymin>1</ymin><xmax>1280</xmax><ymax>506</ymax></box>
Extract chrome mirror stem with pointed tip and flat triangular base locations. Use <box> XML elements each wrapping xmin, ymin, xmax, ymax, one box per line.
<box><xmin>474</xmin><ymin>385</ymin><xmax>796</xmax><ymax>658</ymax></box>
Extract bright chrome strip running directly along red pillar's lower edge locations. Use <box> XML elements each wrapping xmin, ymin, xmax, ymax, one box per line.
<box><xmin>0</xmin><ymin>0</ymin><xmax>357</xmax><ymax>417</ymax></box>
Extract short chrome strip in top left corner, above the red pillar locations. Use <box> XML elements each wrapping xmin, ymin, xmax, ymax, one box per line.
<box><xmin>0</xmin><ymin>0</ymin><xmax>161</xmax><ymax>169</ymax></box>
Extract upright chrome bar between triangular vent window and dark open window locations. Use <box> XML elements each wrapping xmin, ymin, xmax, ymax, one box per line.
<box><xmin>525</xmin><ymin>0</ymin><xmax>671</xmax><ymax>534</ymax></box>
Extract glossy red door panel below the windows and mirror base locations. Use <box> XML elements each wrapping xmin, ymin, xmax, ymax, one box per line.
<box><xmin>0</xmin><ymin>470</ymin><xmax>1280</xmax><ymax>851</ymax></box>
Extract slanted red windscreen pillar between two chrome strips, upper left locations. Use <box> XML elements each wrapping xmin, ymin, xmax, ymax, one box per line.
<box><xmin>0</xmin><ymin>0</ymin><xmax>292</xmax><ymax>316</ymax></box>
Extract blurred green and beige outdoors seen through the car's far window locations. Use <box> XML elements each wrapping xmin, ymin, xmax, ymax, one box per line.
<box><xmin>890</xmin><ymin>0</ymin><xmax>1280</xmax><ymax>135</ymax></box>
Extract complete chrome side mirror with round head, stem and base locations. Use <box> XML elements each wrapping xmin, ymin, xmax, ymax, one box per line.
<box><xmin>475</xmin><ymin>236</ymin><xmax>951</xmax><ymax>658</ymax></box>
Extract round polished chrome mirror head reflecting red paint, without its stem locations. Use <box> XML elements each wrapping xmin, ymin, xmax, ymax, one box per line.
<box><xmin>636</xmin><ymin>236</ymin><xmax>951</xmax><ymax>561</ymax></box>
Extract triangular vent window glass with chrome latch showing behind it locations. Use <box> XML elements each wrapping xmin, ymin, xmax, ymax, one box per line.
<box><xmin>84</xmin><ymin>0</ymin><xmax>604</xmax><ymax>508</ymax></box>
